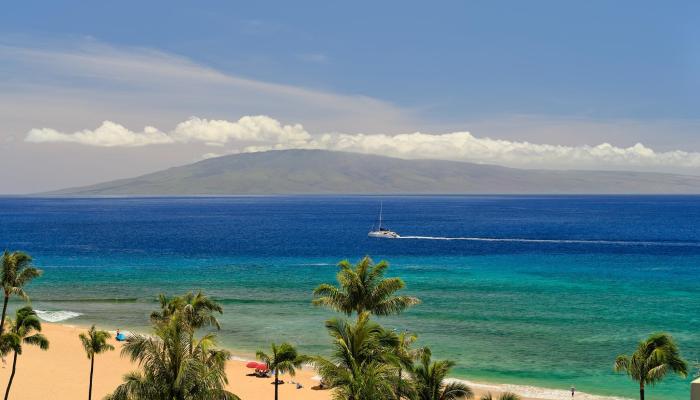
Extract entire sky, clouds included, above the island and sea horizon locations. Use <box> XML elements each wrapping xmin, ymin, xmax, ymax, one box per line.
<box><xmin>0</xmin><ymin>0</ymin><xmax>700</xmax><ymax>194</ymax></box>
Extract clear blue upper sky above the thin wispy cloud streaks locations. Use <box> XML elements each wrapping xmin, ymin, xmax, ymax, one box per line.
<box><xmin>0</xmin><ymin>1</ymin><xmax>700</xmax><ymax>121</ymax></box>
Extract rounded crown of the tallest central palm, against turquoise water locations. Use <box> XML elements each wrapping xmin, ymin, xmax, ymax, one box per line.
<box><xmin>312</xmin><ymin>256</ymin><xmax>420</xmax><ymax>316</ymax></box>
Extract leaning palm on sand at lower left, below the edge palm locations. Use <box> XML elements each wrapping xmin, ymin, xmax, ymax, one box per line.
<box><xmin>3</xmin><ymin>306</ymin><xmax>49</xmax><ymax>400</ymax></box>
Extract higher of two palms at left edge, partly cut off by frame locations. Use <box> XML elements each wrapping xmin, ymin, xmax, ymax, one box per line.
<box><xmin>0</xmin><ymin>250</ymin><xmax>42</xmax><ymax>335</ymax></box>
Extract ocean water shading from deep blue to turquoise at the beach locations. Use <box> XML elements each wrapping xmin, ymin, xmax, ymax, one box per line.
<box><xmin>0</xmin><ymin>196</ymin><xmax>700</xmax><ymax>399</ymax></box>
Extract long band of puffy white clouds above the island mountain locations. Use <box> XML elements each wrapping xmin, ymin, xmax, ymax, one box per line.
<box><xmin>25</xmin><ymin>115</ymin><xmax>700</xmax><ymax>171</ymax></box>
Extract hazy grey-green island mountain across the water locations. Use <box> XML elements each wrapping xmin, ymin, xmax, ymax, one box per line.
<box><xmin>49</xmin><ymin>150</ymin><xmax>700</xmax><ymax>195</ymax></box>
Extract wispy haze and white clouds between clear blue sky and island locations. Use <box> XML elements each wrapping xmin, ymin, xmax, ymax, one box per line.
<box><xmin>0</xmin><ymin>39</ymin><xmax>700</xmax><ymax>193</ymax></box>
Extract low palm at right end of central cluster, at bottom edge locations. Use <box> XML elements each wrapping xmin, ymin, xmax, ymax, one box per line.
<box><xmin>412</xmin><ymin>348</ymin><xmax>474</xmax><ymax>400</ymax></box>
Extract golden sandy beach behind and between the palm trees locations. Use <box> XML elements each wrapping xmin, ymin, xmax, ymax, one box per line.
<box><xmin>0</xmin><ymin>321</ymin><xmax>626</xmax><ymax>400</ymax></box>
